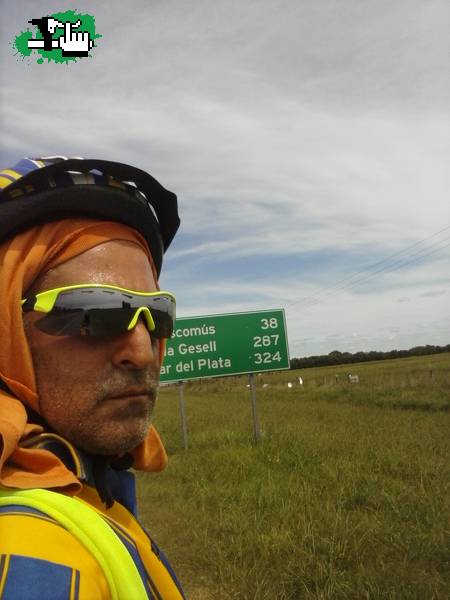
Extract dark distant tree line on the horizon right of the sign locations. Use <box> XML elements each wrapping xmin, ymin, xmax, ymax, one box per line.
<box><xmin>290</xmin><ymin>344</ymin><xmax>450</xmax><ymax>369</ymax></box>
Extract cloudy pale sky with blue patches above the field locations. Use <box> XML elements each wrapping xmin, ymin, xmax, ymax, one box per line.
<box><xmin>0</xmin><ymin>0</ymin><xmax>450</xmax><ymax>357</ymax></box>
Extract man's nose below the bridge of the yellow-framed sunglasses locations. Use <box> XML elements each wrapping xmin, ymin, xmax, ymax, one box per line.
<box><xmin>113</xmin><ymin>315</ymin><xmax>159</xmax><ymax>369</ymax></box>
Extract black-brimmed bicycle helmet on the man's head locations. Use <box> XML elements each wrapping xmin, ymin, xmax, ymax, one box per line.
<box><xmin>0</xmin><ymin>156</ymin><xmax>180</xmax><ymax>275</ymax></box>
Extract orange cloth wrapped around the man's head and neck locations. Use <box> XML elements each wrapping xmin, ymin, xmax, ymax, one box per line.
<box><xmin>0</xmin><ymin>218</ymin><xmax>167</xmax><ymax>494</ymax></box>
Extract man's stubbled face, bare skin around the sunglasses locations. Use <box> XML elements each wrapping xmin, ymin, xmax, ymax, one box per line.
<box><xmin>24</xmin><ymin>240</ymin><xmax>160</xmax><ymax>455</ymax></box>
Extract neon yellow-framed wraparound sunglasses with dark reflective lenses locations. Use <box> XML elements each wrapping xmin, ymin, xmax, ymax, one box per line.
<box><xmin>22</xmin><ymin>283</ymin><xmax>176</xmax><ymax>339</ymax></box>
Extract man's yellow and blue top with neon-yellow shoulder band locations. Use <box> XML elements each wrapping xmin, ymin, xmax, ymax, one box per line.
<box><xmin>0</xmin><ymin>485</ymin><xmax>184</xmax><ymax>600</ymax></box>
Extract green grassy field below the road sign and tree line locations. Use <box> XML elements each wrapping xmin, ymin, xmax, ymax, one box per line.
<box><xmin>138</xmin><ymin>354</ymin><xmax>450</xmax><ymax>600</ymax></box>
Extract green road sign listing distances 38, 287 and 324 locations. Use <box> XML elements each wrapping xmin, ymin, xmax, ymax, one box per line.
<box><xmin>161</xmin><ymin>309</ymin><xmax>289</xmax><ymax>382</ymax></box>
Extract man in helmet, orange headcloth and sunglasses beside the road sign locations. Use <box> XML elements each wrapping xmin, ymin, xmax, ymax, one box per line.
<box><xmin>0</xmin><ymin>157</ymin><xmax>184</xmax><ymax>600</ymax></box>
